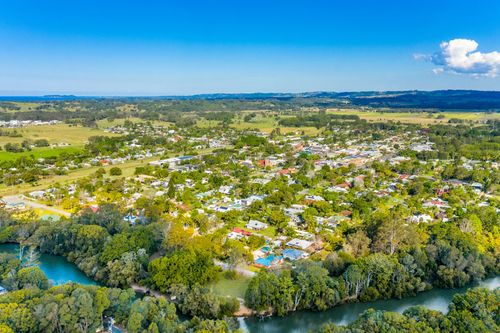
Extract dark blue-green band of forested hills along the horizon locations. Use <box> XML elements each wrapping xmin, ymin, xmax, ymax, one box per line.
<box><xmin>0</xmin><ymin>90</ymin><xmax>500</xmax><ymax>111</ymax></box>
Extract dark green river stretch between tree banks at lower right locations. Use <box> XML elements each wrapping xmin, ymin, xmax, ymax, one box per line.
<box><xmin>239</xmin><ymin>277</ymin><xmax>500</xmax><ymax>333</ymax></box>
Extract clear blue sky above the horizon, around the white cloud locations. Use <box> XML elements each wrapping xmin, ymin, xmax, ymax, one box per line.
<box><xmin>0</xmin><ymin>0</ymin><xmax>500</xmax><ymax>95</ymax></box>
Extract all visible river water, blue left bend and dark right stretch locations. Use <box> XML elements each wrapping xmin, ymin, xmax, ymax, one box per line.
<box><xmin>0</xmin><ymin>244</ymin><xmax>500</xmax><ymax>333</ymax></box>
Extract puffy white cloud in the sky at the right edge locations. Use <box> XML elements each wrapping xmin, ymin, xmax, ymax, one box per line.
<box><xmin>415</xmin><ymin>39</ymin><xmax>500</xmax><ymax>77</ymax></box>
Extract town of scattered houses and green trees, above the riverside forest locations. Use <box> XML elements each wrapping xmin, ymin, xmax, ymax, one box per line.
<box><xmin>3</xmin><ymin>115</ymin><xmax>498</xmax><ymax>272</ymax></box>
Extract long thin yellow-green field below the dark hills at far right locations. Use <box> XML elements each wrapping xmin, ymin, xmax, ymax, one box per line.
<box><xmin>327</xmin><ymin>109</ymin><xmax>500</xmax><ymax>125</ymax></box>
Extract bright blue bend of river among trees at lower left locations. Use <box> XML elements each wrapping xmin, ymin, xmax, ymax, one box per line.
<box><xmin>0</xmin><ymin>243</ymin><xmax>97</xmax><ymax>285</ymax></box>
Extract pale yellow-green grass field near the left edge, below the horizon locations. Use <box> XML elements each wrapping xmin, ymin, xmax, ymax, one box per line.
<box><xmin>0</xmin><ymin>124</ymin><xmax>116</xmax><ymax>146</ymax></box>
